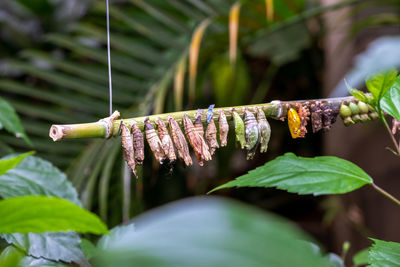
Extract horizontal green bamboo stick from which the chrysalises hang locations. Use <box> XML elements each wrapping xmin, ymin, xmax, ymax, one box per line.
<box><xmin>49</xmin><ymin>96</ymin><xmax>376</xmax><ymax>141</ymax></box>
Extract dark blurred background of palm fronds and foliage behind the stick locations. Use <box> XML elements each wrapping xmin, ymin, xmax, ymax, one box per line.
<box><xmin>0</xmin><ymin>0</ymin><xmax>400</xmax><ymax>264</ymax></box>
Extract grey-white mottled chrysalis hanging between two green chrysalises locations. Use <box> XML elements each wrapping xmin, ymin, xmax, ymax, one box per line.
<box><xmin>244</xmin><ymin>110</ymin><xmax>260</xmax><ymax>160</ymax></box>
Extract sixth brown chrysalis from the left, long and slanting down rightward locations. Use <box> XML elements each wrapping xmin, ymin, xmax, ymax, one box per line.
<box><xmin>183</xmin><ymin>115</ymin><xmax>211</xmax><ymax>166</ymax></box>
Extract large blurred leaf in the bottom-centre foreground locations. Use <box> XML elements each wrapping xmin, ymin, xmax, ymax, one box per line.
<box><xmin>95</xmin><ymin>198</ymin><xmax>329</xmax><ymax>267</ymax></box>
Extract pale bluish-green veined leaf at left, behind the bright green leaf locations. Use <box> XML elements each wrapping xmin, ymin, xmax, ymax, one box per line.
<box><xmin>0</xmin><ymin>156</ymin><xmax>81</xmax><ymax>205</ymax></box>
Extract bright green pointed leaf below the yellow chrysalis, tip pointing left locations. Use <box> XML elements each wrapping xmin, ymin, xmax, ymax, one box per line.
<box><xmin>211</xmin><ymin>153</ymin><xmax>372</xmax><ymax>195</ymax></box>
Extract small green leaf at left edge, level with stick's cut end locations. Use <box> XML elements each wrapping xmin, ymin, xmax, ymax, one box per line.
<box><xmin>0</xmin><ymin>97</ymin><xmax>32</xmax><ymax>145</ymax></box>
